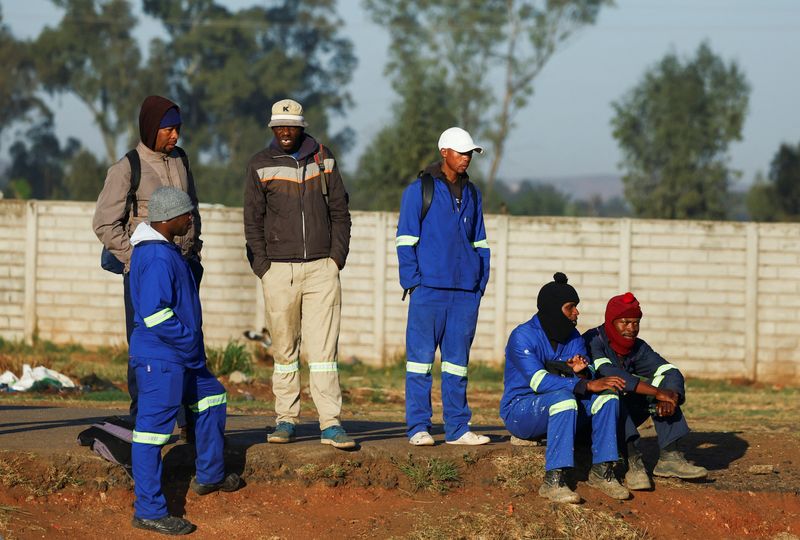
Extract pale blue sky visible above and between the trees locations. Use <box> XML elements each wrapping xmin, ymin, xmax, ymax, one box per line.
<box><xmin>0</xmin><ymin>0</ymin><xmax>800</xmax><ymax>184</ymax></box>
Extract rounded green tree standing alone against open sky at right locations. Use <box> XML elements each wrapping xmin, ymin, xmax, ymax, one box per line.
<box><xmin>611</xmin><ymin>43</ymin><xmax>750</xmax><ymax>219</ymax></box>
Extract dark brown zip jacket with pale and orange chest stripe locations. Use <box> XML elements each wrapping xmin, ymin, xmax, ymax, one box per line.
<box><xmin>244</xmin><ymin>135</ymin><xmax>350</xmax><ymax>277</ymax></box>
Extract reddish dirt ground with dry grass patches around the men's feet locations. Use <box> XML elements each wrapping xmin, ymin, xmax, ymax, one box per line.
<box><xmin>0</xmin><ymin>358</ymin><xmax>800</xmax><ymax>540</ymax></box>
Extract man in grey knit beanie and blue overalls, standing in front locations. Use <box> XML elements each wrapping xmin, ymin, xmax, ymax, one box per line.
<box><xmin>130</xmin><ymin>186</ymin><xmax>241</xmax><ymax>535</ymax></box>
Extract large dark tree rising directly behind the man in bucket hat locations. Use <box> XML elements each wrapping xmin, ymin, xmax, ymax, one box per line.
<box><xmin>144</xmin><ymin>0</ymin><xmax>355</xmax><ymax>205</ymax></box>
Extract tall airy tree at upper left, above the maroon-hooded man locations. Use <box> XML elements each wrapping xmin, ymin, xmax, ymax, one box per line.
<box><xmin>33</xmin><ymin>0</ymin><xmax>153</xmax><ymax>163</ymax></box>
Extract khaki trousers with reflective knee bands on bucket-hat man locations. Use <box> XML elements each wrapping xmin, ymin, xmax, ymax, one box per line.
<box><xmin>261</xmin><ymin>258</ymin><xmax>342</xmax><ymax>429</ymax></box>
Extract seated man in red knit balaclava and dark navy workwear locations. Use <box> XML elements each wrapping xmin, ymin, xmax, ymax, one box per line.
<box><xmin>583</xmin><ymin>292</ymin><xmax>708</xmax><ymax>490</ymax></box>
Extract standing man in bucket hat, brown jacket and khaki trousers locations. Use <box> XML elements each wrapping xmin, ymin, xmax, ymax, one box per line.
<box><xmin>244</xmin><ymin>99</ymin><xmax>355</xmax><ymax>448</ymax></box>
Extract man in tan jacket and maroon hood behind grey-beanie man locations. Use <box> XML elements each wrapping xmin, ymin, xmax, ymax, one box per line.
<box><xmin>92</xmin><ymin>96</ymin><xmax>203</xmax><ymax>427</ymax></box>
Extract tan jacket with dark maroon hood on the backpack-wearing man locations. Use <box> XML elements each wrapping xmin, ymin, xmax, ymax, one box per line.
<box><xmin>92</xmin><ymin>96</ymin><xmax>202</xmax><ymax>272</ymax></box>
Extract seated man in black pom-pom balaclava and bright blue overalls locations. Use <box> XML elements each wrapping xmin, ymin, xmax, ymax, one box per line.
<box><xmin>500</xmin><ymin>272</ymin><xmax>630</xmax><ymax>503</ymax></box>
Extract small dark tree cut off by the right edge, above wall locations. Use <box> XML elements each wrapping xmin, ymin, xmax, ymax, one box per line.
<box><xmin>746</xmin><ymin>143</ymin><xmax>800</xmax><ymax>221</ymax></box>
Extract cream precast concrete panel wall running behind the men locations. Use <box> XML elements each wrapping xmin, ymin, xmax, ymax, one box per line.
<box><xmin>0</xmin><ymin>200</ymin><xmax>800</xmax><ymax>383</ymax></box>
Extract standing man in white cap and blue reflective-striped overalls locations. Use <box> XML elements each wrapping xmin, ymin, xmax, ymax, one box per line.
<box><xmin>395</xmin><ymin>127</ymin><xmax>489</xmax><ymax>446</ymax></box>
